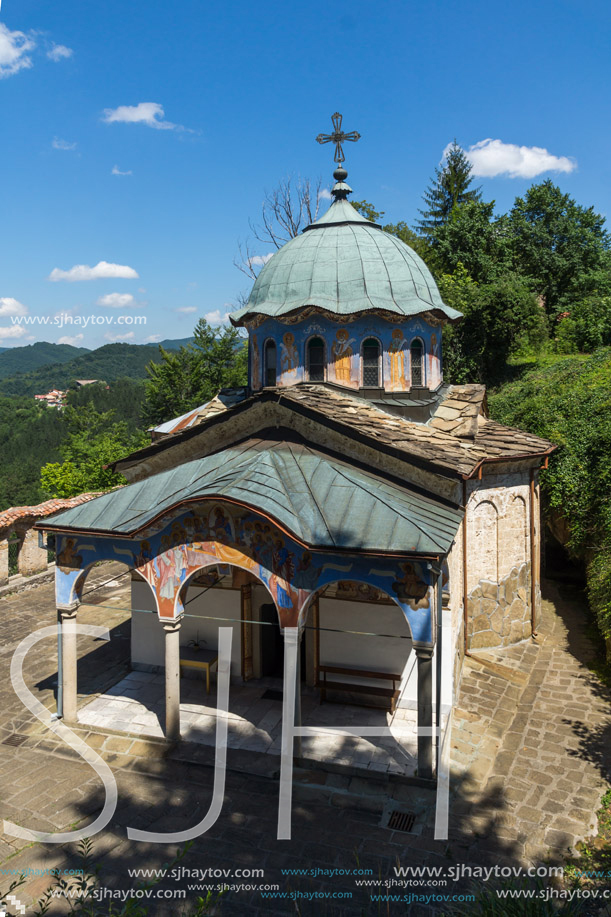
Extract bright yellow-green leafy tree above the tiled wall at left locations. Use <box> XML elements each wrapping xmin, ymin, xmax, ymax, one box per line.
<box><xmin>40</xmin><ymin>404</ymin><xmax>148</xmax><ymax>497</ymax></box>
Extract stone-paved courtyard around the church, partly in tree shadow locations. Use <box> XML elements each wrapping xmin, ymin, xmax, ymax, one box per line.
<box><xmin>0</xmin><ymin>564</ymin><xmax>611</xmax><ymax>917</ymax></box>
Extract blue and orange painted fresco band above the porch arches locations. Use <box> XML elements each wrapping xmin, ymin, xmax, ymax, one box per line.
<box><xmin>51</xmin><ymin>502</ymin><xmax>432</xmax><ymax>643</ymax></box>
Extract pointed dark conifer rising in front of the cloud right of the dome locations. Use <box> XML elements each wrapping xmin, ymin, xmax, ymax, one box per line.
<box><xmin>418</xmin><ymin>140</ymin><xmax>482</xmax><ymax>238</ymax></box>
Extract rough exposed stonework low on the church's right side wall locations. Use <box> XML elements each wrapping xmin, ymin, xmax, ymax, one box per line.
<box><xmin>467</xmin><ymin>561</ymin><xmax>532</xmax><ymax>650</ymax></box>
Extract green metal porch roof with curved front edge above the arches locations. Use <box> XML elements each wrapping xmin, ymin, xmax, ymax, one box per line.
<box><xmin>44</xmin><ymin>439</ymin><xmax>463</xmax><ymax>554</ymax></box>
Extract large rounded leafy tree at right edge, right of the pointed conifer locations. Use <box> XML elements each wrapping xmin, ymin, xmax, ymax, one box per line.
<box><xmin>509</xmin><ymin>179</ymin><xmax>611</xmax><ymax>316</ymax></box>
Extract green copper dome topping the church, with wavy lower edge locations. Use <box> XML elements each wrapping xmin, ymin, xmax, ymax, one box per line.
<box><xmin>231</xmin><ymin>182</ymin><xmax>461</xmax><ymax>325</ymax></box>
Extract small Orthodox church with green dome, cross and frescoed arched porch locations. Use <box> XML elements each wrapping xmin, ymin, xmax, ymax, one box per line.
<box><xmin>40</xmin><ymin>125</ymin><xmax>553</xmax><ymax>779</ymax></box>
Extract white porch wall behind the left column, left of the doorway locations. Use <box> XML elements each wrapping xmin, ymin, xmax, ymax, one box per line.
<box><xmin>132</xmin><ymin>580</ymin><xmax>242</xmax><ymax>681</ymax></box>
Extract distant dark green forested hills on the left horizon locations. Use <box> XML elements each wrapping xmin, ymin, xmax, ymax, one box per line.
<box><xmin>0</xmin><ymin>338</ymin><xmax>191</xmax><ymax>396</ymax></box>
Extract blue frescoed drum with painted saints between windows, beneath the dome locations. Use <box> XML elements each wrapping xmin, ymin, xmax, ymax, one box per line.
<box><xmin>249</xmin><ymin>309</ymin><xmax>441</xmax><ymax>392</ymax></box>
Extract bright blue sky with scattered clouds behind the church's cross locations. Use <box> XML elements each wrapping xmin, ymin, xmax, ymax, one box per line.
<box><xmin>0</xmin><ymin>0</ymin><xmax>611</xmax><ymax>348</ymax></box>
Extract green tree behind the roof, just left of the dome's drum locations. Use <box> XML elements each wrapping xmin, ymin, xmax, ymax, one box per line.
<box><xmin>143</xmin><ymin>318</ymin><xmax>248</xmax><ymax>424</ymax></box>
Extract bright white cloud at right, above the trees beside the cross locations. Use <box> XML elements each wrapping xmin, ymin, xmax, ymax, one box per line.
<box><xmin>460</xmin><ymin>138</ymin><xmax>577</xmax><ymax>178</ymax></box>
